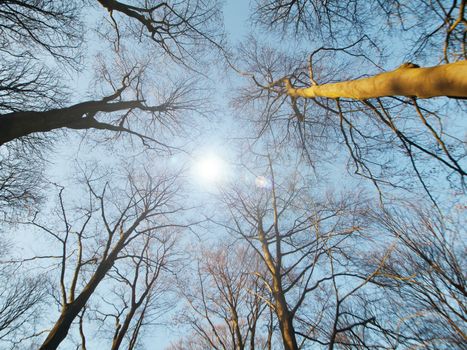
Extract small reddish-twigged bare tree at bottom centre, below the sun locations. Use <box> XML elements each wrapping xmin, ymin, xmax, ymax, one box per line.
<box><xmin>175</xmin><ymin>242</ymin><xmax>273</xmax><ymax>350</ymax></box>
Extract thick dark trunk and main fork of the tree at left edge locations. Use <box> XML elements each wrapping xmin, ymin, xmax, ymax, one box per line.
<box><xmin>0</xmin><ymin>101</ymin><xmax>154</xmax><ymax>146</ymax></box>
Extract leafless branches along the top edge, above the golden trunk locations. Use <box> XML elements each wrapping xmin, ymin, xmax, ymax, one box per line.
<box><xmin>252</xmin><ymin>0</ymin><xmax>466</xmax><ymax>62</ymax></box>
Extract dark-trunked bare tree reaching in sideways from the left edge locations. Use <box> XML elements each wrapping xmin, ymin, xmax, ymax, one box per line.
<box><xmin>0</xmin><ymin>72</ymin><xmax>196</xmax><ymax>145</ymax></box>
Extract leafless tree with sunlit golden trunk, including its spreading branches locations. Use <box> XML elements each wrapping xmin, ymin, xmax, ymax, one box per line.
<box><xmin>236</xmin><ymin>21</ymin><xmax>467</xmax><ymax>202</ymax></box>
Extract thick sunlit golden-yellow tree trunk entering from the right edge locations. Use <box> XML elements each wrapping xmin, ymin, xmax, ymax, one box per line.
<box><xmin>285</xmin><ymin>61</ymin><xmax>467</xmax><ymax>100</ymax></box>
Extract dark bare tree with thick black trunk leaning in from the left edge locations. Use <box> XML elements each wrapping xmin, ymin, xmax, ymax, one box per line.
<box><xmin>0</xmin><ymin>62</ymin><xmax>206</xmax><ymax>146</ymax></box>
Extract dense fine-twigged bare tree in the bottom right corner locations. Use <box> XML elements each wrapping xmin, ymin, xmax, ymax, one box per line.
<box><xmin>375</xmin><ymin>205</ymin><xmax>467</xmax><ymax>349</ymax></box>
